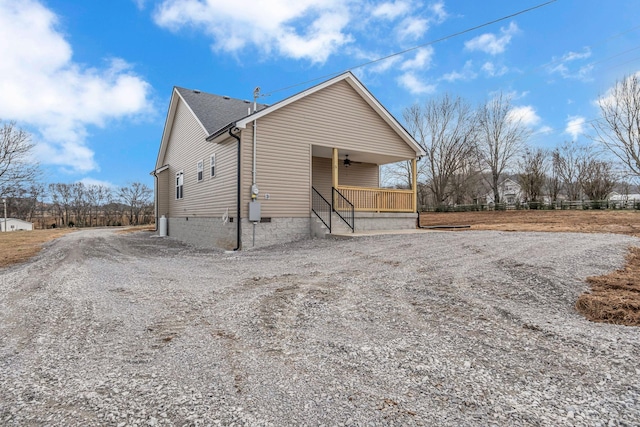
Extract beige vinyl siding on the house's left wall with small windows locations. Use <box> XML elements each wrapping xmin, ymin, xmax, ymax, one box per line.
<box><xmin>162</xmin><ymin>100</ymin><xmax>237</xmax><ymax>218</ymax></box>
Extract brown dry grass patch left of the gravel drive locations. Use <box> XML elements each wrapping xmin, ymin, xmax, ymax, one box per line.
<box><xmin>0</xmin><ymin>228</ymin><xmax>73</xmax><ymax>268</ymax></box>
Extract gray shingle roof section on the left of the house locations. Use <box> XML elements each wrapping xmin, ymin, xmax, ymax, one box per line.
<box><xmin>176</xmin><ymin>86</ymin><xmax>266</xmax><ymax>135</ymax></box>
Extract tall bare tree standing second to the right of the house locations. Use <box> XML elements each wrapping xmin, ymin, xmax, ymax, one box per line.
<box><xmin>477</xmin><ymin>93</ymin><xmax>531</xmax><ymax>203</ymax></box>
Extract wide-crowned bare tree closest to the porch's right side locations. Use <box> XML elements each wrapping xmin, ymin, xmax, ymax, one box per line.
<box><xmin>403</xmin><ymin>95</ymin><xmax>476</xmax><ymax>204</ymax></box>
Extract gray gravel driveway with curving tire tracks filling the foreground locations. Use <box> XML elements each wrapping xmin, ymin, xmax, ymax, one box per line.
<box><xmin>0</xmin><ymin>229</ymin><xmax>640</xmax><ymax>426</ymax></box>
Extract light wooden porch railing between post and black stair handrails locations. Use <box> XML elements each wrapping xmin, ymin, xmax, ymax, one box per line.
<box><xmin>338</xmin><ymin>185</ymin><xmax>414</xmax><ymax>212</ymax></box>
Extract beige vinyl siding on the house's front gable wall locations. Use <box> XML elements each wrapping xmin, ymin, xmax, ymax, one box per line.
<box><xmin>248</xmin><ymin>82</ymin><xmax>402</xmax><ymax>217</ymax></box>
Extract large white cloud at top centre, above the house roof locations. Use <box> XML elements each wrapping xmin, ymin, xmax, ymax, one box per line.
<box><xmin>154</xmin><ymin>0</ymin><xmax>352</xmax><ymax>63</ymax></box>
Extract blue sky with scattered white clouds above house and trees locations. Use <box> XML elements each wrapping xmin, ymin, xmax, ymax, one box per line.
<box><xmin>0</xmin><ymin>0</ymin><xmax>640</xmax><ymax>186</ymax></box>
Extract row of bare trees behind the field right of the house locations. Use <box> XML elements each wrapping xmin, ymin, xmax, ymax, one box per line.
<box><xmin>386</xmin><ymin>75</ymin><xmax>640</xmax><ymax>206</ymax></box>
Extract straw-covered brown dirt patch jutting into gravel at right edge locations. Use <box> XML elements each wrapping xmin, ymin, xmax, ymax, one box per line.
<box><xmin>576</xmin><ymin>248</ymin><xmax>640</xmax><ymax>326</ymax></box>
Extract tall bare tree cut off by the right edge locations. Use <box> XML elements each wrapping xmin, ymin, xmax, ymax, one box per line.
<box><xmin>592</xmin><ymin>73</ymin><xmax>640</xmax><ymax>177</ymax></box>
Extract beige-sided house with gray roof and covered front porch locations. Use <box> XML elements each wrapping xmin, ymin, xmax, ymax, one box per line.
<box><xmin>152</xmin><ymin>72</ymin><xmax>425</xmax><ymax>249</ymax></box>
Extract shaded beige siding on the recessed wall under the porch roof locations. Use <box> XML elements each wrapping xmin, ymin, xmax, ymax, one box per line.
<box><xmin>312</xmin><ymin>157</ymin><xmax>380</xmax><ymax>200</ymax></box>
